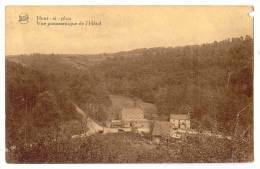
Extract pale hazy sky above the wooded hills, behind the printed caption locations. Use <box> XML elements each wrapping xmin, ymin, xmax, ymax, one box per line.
<box><xmin>6</xmin><ymin>6</ymin><xmax>253</xmax><ymax>55</ymax></box>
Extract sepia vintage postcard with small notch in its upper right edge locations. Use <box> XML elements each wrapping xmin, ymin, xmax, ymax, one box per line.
<box><xmin>5</xmin><ymin>6</ymin><xmax>254</xmax><ymax>163</ymax></box>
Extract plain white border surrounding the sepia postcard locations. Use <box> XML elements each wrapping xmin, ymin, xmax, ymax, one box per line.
<box><xmin>0</xmin><ymin>0</ymin><xmax>260</xmax><ymax>169</ymax></box>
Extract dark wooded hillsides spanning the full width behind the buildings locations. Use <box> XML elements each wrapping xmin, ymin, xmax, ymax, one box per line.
<box><xmin>6</xmin><ymin>36</ymin><xmax>253</xmax><ymax>162</ymax></box>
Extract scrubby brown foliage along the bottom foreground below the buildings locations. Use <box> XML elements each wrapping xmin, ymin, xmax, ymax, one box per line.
<box><xmin>7</xmin><ymin>133</ymin><xmax>252</xmax><ymax>163</ymax></box>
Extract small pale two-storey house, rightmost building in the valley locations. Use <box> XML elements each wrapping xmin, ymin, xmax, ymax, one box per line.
<box><xmin>170</xmin><ymin>114</ymin><xmax>190</xmax><ymax>130</ymax></box>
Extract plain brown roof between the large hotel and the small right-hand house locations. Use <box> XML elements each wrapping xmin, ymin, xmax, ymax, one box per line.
<box><xmin>152</xmin><ymin>121</ymin><xmax>170</xmax><ymax>137</ymax></box>
